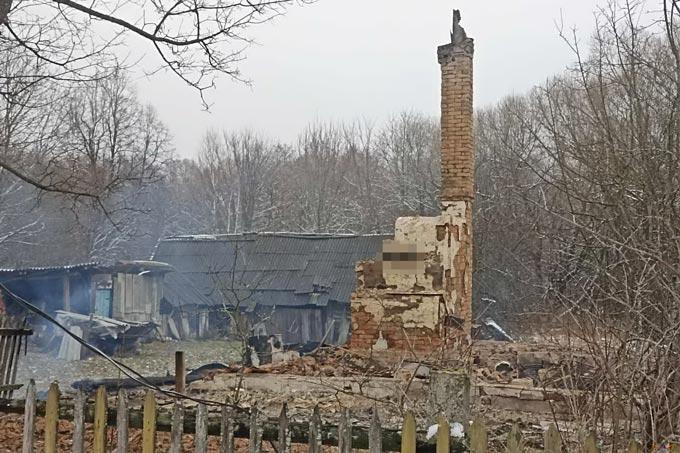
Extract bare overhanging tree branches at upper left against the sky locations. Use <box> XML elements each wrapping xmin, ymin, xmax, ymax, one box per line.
<box><xmin>0</xmin><ymin>0</ymin><xmax>311</xmax><ymax>200</ymax></box>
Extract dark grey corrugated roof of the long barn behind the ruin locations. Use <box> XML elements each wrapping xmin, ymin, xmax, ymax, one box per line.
<box><xmin>153</xmin><ymin>233</ymin><xmax>392</xmax><ymax>306</ymax></box>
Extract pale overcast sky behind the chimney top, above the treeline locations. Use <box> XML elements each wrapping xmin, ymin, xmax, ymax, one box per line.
<box><xmin>136</xmin><ymin>0</ymin><xmax>601</xmax><ymax>157</ymax></box>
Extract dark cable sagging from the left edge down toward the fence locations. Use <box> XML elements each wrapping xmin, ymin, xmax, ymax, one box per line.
<box><xmin>0</xmin><ymin>283</ymin><xmax>235</xmax><ymax>410</ymax></box>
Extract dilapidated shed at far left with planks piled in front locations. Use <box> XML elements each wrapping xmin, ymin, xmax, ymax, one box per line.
<box><xmin>0</xmin><ymin>261</ymin><xmax>171</xmax><ymax>360</ymax></box>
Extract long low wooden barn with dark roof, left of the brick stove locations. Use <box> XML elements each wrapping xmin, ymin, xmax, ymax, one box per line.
<box><xmin>154</xmin><ymin>233</ymin><xmax>386</xmax><ymax>345</ymax></box>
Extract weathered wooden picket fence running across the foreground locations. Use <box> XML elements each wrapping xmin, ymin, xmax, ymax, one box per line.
<box><xmin>22</xmin><ymin>382</ymin><xmax>643</xmax><ymax>453</ymax></box>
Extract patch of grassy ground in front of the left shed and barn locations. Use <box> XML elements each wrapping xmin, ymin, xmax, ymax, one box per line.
<box><xmin>16</xmin><ymin>340</ymin><xmax>240</xmax><ymax>394</ymax></box>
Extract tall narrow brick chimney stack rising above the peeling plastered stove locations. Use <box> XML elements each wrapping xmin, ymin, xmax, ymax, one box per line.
<box><xmin>437</xmin><ymin>10</ymin><xmax>474</xmax><ymax>204</ymax></box>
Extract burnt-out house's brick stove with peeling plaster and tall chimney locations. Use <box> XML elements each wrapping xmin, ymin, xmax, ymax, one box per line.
<box><xmin>351</xmin><ymin>11</ymin><xmax>474</xmax><ymax>358</ymax></box>
